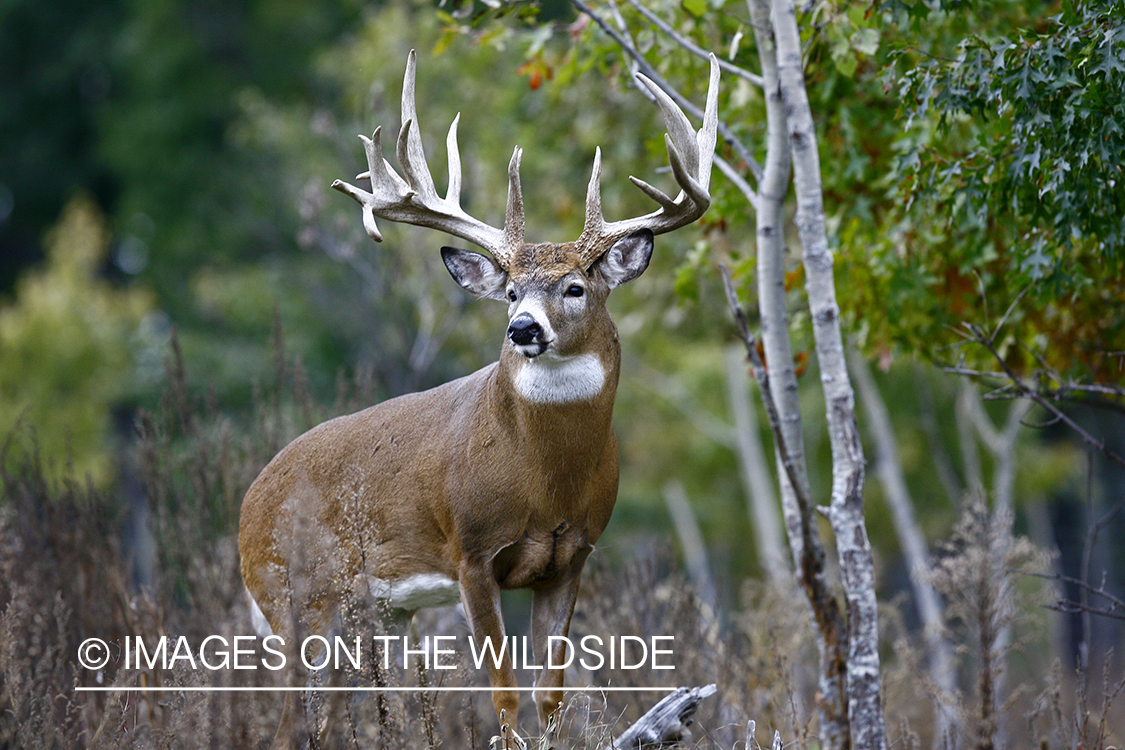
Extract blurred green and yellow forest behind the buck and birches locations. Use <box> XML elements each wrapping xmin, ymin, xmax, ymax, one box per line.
<box><xmin>0</xmin><ymin>0</ymin><xmax>1125</xmax><ymax>747</ymax></box>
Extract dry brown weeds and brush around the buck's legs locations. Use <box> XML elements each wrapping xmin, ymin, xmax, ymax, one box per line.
<box><xmin>0</xmin><ymin>344</ymin><xmax>1123</xmax><ymax>750</ymax></box>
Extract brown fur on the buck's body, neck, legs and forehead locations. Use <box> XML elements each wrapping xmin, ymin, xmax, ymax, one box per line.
<box><xmin>239</xmin><ymin>240</ymin><xmax>630</xmax><ymax>744</ymax></box>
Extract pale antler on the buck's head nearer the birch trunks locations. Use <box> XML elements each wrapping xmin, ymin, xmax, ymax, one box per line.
<box><xmin>576</xmin><ymin>54</ymin><xmax>719</xmax><ymax>268</ymax></box>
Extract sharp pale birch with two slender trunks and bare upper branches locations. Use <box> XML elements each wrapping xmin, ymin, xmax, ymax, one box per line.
<box><xmin>492</xmin><ymin>0</ymin><xmax>887</xmax><ymax>749</ymax></box>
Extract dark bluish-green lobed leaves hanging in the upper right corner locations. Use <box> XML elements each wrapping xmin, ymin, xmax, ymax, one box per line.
<box><xmin>897</xmin><ymin>2</ymin><xmax>1125</xmax><ymax>278</ymax></box>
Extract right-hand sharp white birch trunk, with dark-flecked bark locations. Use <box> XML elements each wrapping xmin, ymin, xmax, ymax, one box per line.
<box><xmin>772</xmin><ymin>0</ymin><xmax>887</xmax><ymax>750</ymax></box>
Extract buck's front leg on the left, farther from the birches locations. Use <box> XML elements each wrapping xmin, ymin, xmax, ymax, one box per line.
<box><xmin>459</xmin><ymin>562</ymin><xmax>520</xmax><ymax>730</ymax></box>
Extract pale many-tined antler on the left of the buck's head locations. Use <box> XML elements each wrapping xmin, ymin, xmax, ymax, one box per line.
<box><xmin>332</xmin><ymin>49</ymin><xmax>524</xmax><ymax>269</ymax></box>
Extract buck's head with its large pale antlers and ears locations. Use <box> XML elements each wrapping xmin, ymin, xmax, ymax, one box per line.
<box><xmin>332</xmin><ymin>51</ymin><xmax>719</xmax><ymax>359</ymax></box>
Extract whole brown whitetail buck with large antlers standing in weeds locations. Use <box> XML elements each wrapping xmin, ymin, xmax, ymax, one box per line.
<box><xmin>239</xmin><ymin>52</ymin><xmax>719</xmax><ymax>744</ymax></box>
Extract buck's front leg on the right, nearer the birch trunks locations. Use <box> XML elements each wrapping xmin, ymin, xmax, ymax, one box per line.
<box><xmin>531</xmin><ymin>549</ymin><xmax>590</xmax><ymax>732</ymax></box>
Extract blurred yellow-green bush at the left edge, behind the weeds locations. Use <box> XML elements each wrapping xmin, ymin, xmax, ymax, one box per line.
<box><xmin>0</xmin><ymin>199</ymin><xmax>153</xmax><ymax>486</ymax></box>
